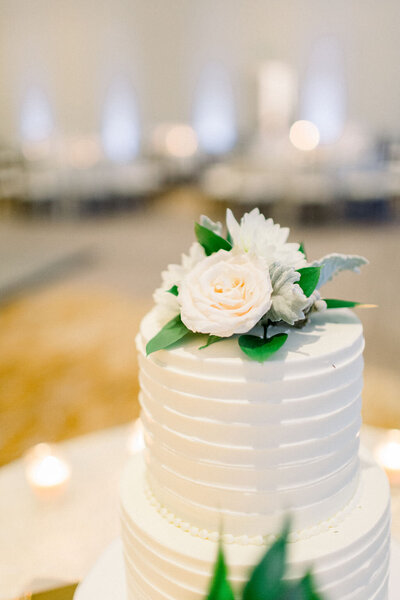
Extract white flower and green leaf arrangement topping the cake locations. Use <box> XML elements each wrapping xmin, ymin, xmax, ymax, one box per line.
<box><xmin>146</xmin><ymin>209</ymin><xmax>367</xmax><ymax>362</ymax></box>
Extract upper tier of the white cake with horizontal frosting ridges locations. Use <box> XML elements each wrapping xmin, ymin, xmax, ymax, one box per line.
<box><xmin>137</xmin><ymin>310</ymin><xmax>364</xmax><ymax>536</ymax></box>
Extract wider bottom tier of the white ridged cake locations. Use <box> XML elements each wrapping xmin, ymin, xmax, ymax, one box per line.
<box><xmin>121</xmin><ymin>455</ymin><xmax>390</xmax><ymax>600</ymax></box>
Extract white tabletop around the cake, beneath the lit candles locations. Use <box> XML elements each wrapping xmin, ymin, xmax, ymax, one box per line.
<box><xmin>0</xmin><ymin>425</ymin><xmax>400</xmax><ymax>600</ymax></box>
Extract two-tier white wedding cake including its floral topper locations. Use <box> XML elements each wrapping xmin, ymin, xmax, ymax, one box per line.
<box><xmin>121</xmin><ymin>210</ymin><xmax>390</xmax><ymax>600</ymax></box>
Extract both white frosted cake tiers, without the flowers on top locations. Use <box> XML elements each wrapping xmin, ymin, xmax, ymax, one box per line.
<box><xmin>121</xmin><ymin>310</ymin><xmax>390</xmax><ymax>600</ymax></box>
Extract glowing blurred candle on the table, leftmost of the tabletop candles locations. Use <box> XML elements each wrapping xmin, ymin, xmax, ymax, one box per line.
<box><xmin>25</xmin><ymin>444</ymin><xmax>71</xmax><ymax>498</ymax></box>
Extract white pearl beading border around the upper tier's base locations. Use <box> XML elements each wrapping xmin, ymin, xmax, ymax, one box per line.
<box><xmin>144</xmin><ymin>481</ymin><xmax>361</xmax><ymax>546</ymax></box>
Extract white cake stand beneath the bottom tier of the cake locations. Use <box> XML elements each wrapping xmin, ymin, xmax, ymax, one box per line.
<box><xmin>74</xmin><ymin>539</ymin><xmax>400</xmax><ymax>600</ymax></box>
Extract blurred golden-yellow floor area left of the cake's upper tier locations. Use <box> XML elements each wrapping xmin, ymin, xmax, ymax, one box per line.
<box><xmin>0</xmin><ymin>284</ymin><xmax>147</xmax><ymax>465</ymax></box>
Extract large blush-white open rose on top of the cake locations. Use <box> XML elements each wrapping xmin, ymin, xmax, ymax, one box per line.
<box><xmin>178</xmin><ymin>250</ymin><xmax>272</xmax><ymax>337</ymax></box>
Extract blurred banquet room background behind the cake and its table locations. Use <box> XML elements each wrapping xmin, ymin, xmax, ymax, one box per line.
<box><xmin>0</xmin><ymin>0</ymin><xmax>400</xmax><ymax>464</ymax></box>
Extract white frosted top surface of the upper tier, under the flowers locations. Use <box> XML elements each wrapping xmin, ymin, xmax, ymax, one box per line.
<box><xmin>138</xmin><ymin>309</ymin><xmax>364</xmax><ymax>379</ymax></box>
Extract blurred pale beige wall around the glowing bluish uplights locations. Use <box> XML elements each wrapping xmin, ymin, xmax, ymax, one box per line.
<box><xmin>0</xmin><ymin>0</ymin><xmax>400</xmax><ymax>141</ymax></box>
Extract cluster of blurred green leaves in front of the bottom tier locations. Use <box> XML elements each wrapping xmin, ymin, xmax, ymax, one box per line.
<box><xmin>207</xmin><ymin>521</ymin><xmax>323</xmax><ymax>600</ymax></box>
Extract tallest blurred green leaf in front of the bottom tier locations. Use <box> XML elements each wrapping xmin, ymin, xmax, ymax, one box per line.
<box><xmin>243</xmin><ymin>520</ymin><xmax>289</xmax><ymax>600</ymax></box>
